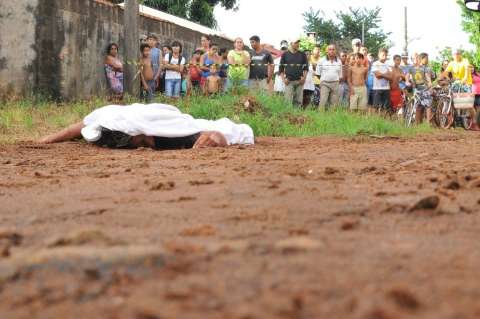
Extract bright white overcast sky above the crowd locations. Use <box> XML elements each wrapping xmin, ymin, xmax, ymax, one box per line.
<box><xmin>215</xmin><ymin>0</ymin><xmax>472</xmax><ymax>57</ymax></box>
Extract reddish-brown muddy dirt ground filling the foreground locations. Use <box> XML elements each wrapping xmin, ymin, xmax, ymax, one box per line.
<box><xmin>0</xmin><ymin>133</ymin><xmax>480</xmax><ymax>319</ymax></box>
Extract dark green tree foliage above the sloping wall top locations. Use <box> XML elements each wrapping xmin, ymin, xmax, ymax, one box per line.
<box><xmin>109</xmin><ymin>0</ymin><xmax>238</xmax><ymax>28</ymax></box>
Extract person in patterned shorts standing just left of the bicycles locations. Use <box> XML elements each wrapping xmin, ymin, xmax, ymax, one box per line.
<box><xmin>410</xmin><ymin>53</ymin><xmax>433</xmax><ymax>124</ymax></box>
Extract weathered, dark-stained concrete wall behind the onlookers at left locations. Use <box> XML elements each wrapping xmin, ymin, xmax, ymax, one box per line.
<box><xmin>0</xmin><ymin>0</ymin><xmax>232</xmax><ymax>99</ymax></box>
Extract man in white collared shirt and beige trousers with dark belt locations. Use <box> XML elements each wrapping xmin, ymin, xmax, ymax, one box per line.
<box><xmin>316</xmin><ymin>44</ymin><xmax>343</xmax><ymax>110</ymax></box>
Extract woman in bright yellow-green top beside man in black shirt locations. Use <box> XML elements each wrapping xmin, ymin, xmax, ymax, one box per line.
<box><xmin>227</xmin><ymin>38</ymin><xmax>251</xmax><ymax>88</ymax></box>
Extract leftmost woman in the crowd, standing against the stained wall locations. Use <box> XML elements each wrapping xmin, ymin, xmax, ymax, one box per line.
<box><xmin>105</xmin><ymin>43</ymin><xmax>123</xmax><ymax>100</ymax></box>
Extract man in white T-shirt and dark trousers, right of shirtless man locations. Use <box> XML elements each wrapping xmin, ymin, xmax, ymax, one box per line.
<box><xmin>372</xmin><ymin>48</ymin><xmax>392</xmax><ymax>112</ymax></box>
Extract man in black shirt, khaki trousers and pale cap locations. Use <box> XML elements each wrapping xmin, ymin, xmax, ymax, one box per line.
<box><xmin>279</xmin><ymin>39</ymin><xmax>308</xmax><ymax>106</ymax></box>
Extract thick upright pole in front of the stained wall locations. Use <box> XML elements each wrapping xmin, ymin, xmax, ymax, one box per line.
<box><xmin>123</xmin><ymin>0</ymin><xmax>140</xmax><ymax>97</ymax></box>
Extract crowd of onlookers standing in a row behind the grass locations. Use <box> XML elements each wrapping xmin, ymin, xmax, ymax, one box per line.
<box><xmin>105</xmin><ymin>35</ymin><xmax>480</xmax><ymax>127</ymax></box>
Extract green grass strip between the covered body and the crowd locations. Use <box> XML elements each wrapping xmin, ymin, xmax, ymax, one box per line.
<box><xmin>0</xmin><ymin>94</ymin><xmax>433</xmax><ymax>144</ymax></box>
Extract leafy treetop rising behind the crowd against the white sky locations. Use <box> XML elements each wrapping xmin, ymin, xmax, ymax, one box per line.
<box><xmin>303</xmin><ymin>7</ymin><xmax>392</xmax><ymax>53</ymax></box>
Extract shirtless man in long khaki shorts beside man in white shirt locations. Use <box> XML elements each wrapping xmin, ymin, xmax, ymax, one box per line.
<box><xmin>348</xmin><ymin>53</ymin><xmax>368</xmax><ymax>111</ymax></box>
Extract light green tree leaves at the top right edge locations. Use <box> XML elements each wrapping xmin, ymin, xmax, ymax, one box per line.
<box><xmin>457</xmin><ymin>0</ymin><xmax>480</xmax><ymax>66</ymax></box>
